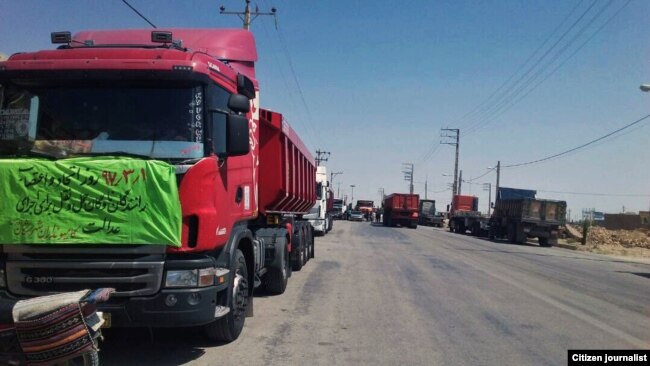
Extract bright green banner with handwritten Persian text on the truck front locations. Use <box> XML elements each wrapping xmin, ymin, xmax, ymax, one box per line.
<box><xmin>0</xmin><ymin>157</ymin><xmax>181</xmax><ymax>247</ymax></box>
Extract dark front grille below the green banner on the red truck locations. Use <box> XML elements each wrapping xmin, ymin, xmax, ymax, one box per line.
<box><xmin>5</xmin><ymin>245</ymin><xmax>165</xmax><ymax>297</ymax></box>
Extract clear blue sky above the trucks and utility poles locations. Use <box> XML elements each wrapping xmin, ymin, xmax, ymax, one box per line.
<box><xmin>0</xmin><ymin>0</ymin><xmax>650</xmax><ymax>217</ymax></box>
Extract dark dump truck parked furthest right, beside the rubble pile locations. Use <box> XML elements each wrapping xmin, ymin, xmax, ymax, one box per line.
<box><xmin>489</xmin><ymin>187</ymin><xmax>566</xmax><ymax>247</ymax></box>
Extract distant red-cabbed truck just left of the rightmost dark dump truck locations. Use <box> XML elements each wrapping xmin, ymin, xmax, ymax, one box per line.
<box><xmin>449</xmin><ymin>195</ymin><xmax>489</xmax><ymax>236</ymax></box>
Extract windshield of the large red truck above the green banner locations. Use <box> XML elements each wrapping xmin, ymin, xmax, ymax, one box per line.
<box><xmin>0</xmin><ymin>84</ymin><xmax>204</xmax><ymax>159</ymax></box>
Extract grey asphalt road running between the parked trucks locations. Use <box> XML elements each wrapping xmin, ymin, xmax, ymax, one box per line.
<box><xmin>101</xmin><ymin>221</ymin><xmax>650</xmax><ymax>365</ymax></box>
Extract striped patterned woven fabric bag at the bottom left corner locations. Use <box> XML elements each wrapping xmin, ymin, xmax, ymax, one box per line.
<box><xmin>15</xmin><ymin>296</ymin><xmax>97</xmax><ymax>365</ymax></box>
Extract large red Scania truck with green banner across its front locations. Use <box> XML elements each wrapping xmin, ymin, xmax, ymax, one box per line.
<box><xmin>0</xmin><ymin>29</ymin><xmax>316</xmax><ymax>341</ymax></box>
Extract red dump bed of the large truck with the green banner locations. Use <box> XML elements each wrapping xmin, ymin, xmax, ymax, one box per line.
<box><xmin>259</xmin><ymin>109</ymin><xmax>316</xmax><ymax>214</ymax></box>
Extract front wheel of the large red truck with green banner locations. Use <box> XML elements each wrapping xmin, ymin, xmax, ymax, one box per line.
<box><xmin>204</xmin><ymin>249</ymin><xmax>250</xmax><ymax>342</ymax></box>
